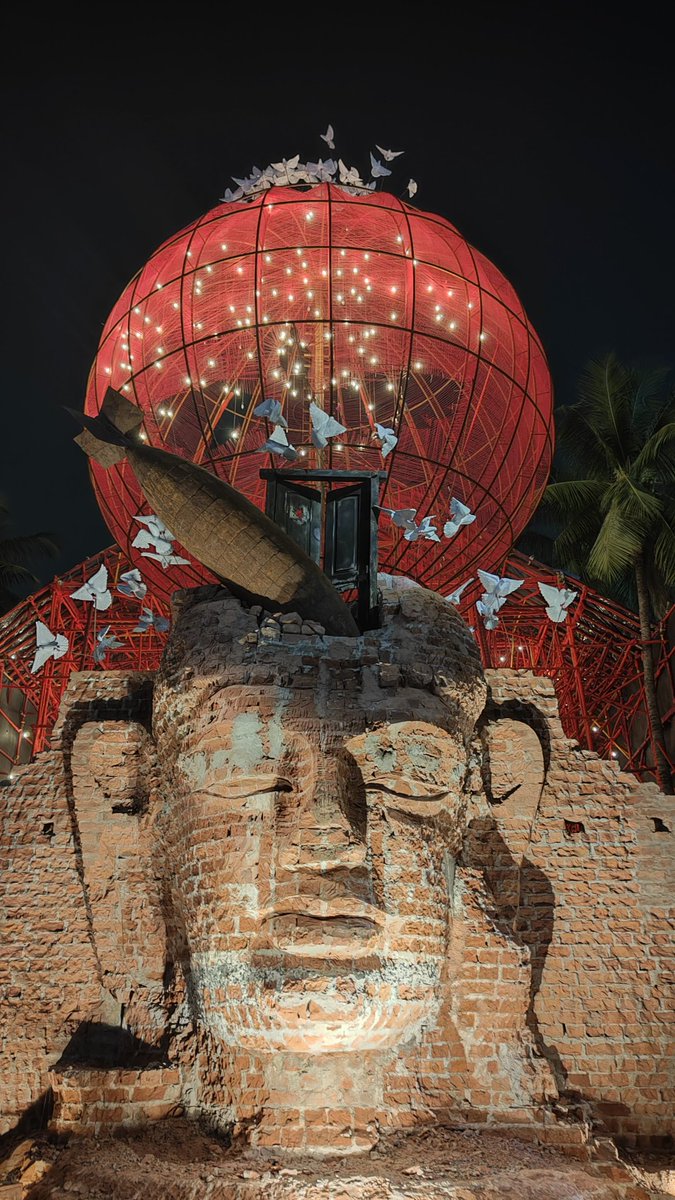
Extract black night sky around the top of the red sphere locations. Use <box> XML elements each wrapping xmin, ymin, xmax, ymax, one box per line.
<box><xmin>0</xmin><ymin>4</ymin><xmax>675</xmax><ymax>582</ymax></box>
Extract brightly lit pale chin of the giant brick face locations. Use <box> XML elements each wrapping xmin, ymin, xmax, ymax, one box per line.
<box><xmin>190</xmin><ymin>952</ymin><xmax>443</xmax><ymax>1055</ymax></box>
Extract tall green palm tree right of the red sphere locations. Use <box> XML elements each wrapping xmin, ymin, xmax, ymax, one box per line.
<box><xmin>543</xmin><ymin>354</ymin><xmax>675</xmax><ymax>794</ymax></box>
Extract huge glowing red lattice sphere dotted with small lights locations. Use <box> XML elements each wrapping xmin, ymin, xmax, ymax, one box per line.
<box><xmin>85</xmin><ymin>184</ymin><xmax>552</xmax><ymax>594</ymax></box>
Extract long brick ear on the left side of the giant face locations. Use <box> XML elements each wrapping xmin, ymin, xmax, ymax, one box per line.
<box><xmin>71</xmin><ymin>720</ymin><xmax>166</xmax><ymax>1036</ymax></box>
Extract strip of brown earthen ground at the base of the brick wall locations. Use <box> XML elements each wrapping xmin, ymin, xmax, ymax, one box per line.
<box><xmin>0</xmin><ymin>1120</ymin><xmax>667</xmax><ymax>1200</ymax></box>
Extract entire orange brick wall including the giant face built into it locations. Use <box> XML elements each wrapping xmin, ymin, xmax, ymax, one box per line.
<box><xmin>0</xmin><ymin>589</ymin><xmax>674</xmax><ymax>1151</ymax></box>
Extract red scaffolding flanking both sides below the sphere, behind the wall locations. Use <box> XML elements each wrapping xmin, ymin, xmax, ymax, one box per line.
<box><xmin>0</xmin><ymin>546</ymin><xmax>675</xmax><ymax>779</ymax></box>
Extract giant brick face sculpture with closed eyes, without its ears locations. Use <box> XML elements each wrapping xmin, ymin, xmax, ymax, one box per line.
<box><xmin>155</xmin><ymin>580</ymin><xmax>484</xmax><ymax>1054</ymax></box>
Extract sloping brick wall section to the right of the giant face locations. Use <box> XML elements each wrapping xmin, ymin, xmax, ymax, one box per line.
<box><xmin>474</xmin><ymin>671</ymin><xmax>675</xmax><ymax>1145</ymax></box>
